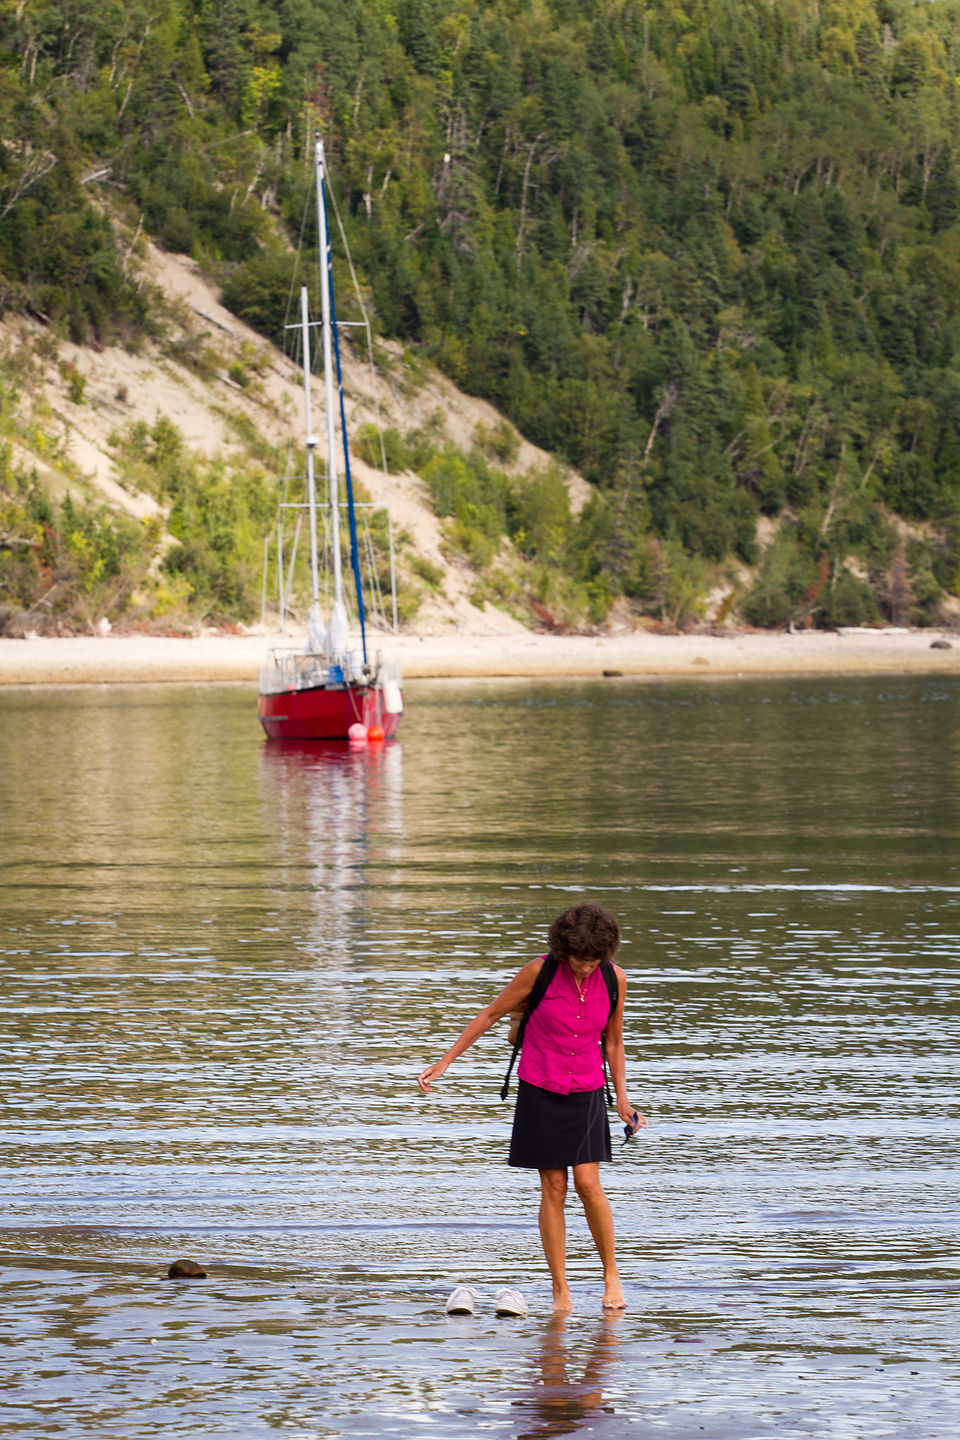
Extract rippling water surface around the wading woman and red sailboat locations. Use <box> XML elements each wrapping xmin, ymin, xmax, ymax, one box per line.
<box><xmin>0</xmin><ymin>678</ymin><xmax>960</xmax><ymax>1440</ymax></box>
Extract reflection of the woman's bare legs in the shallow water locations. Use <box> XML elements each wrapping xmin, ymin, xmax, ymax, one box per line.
<box><xmin>517</xmin><ymin>1315</ymin><xmax>617</xmax><ymax>1440</ymax></box>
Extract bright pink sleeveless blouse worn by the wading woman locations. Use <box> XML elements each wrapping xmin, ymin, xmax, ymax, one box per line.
<box><xmin>517</xmin><ymin>960</ymin><xmax>610</xmax><ymax>1094</ymax></box>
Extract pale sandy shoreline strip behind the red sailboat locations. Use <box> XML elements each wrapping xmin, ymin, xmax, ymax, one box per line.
<box><xmin>0</xmin><ymin>628</ymin><xmax>960</xmax><ymax>687</ymax></box>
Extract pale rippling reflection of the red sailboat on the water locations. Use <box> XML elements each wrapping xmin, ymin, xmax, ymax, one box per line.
<box><xmin>261</xmin><ymin>742</ymin><xmax>403</xmax><ymax>965</ymax></box>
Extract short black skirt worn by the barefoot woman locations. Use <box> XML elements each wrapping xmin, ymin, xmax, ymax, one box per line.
<box><xmin>510</xmin><ymin>1080</ymin><xmax>612</xmax><ymax>1169</ymax></box>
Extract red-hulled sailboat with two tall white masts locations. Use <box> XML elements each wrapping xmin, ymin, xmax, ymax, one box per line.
<box><xmin>258</xmin><ymin>134</ymin><xmax>403</xmax><ymax>740</ymax></box>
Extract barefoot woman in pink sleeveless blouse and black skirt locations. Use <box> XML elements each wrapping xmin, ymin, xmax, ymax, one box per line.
<box><xmin>417</xmin><ymin>904</ymin><xmax>648</xmax><ymax>1312</ymax></box>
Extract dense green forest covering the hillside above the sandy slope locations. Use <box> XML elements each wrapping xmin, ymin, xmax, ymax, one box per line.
<box><xmin>0</xmin><ymin>0</ymin><xmax>960</xmax><ymax>625</ymax></box>
